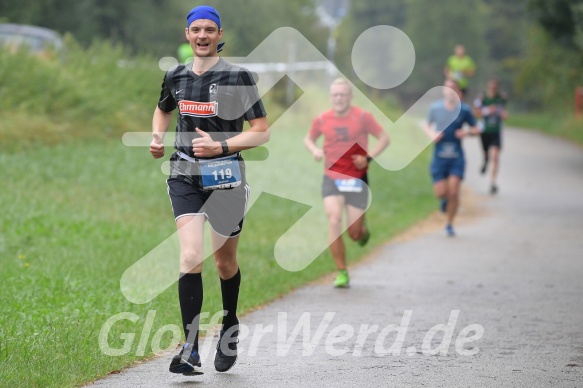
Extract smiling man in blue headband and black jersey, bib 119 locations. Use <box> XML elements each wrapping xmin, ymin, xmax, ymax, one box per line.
<box><xmin>150</xmin><ymin>6</ymin><xmax>269</xmax><ymax>375</ymax></box>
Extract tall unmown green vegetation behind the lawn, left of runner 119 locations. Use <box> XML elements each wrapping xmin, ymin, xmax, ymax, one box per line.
<box><xmin>0</xmin><ymin>36</ymin><xmax>163</xmax><ymax>150</ymax></box>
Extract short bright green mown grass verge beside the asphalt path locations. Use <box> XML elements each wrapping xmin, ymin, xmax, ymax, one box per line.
<box><xmin>0</xmin><ymin>135</ymin><xmax>435</xmax><ymax>386</ymax></box>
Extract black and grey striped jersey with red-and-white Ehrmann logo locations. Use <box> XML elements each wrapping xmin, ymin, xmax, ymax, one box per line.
<box><xmin>158</xmin><ymin>58</ymin><xmax>267</xmax><ymax>156</ymax></box>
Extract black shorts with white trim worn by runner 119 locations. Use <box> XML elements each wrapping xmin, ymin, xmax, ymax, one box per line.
<box><xmin>166</xmin><ymin>155</ymin><xmax>250</xmax><ymax>237</ymax></box>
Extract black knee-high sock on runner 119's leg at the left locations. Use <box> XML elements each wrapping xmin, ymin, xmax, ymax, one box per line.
<box><xmin>178</xmin><ymin>273</ymin><xmax>202</xmax><ymax>351</ymax></box>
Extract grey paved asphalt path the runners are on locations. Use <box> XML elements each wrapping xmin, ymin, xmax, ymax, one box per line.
<box><xmin>94</xmin><ymin>130</ymin><xmax>583</xmax><ymax>388</ymax></box>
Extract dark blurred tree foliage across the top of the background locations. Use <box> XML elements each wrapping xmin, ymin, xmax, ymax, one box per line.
<box><xmin>0</xmin><ymin>0</ymin><xmax>583</xmax><ymax>110</ymax></box>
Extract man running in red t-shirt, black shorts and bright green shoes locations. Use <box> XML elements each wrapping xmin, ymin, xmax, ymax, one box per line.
<box><xmin>304</xmin><ymin>79</ymin><xmax>389</xmax><ymax>287</ymax></box>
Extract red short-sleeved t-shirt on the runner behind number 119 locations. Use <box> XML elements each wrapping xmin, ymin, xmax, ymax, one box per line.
<box><xmin>310</xmin><ymin>106</ymin><xmax>383</xmax><ymax>179</ymax></box>
